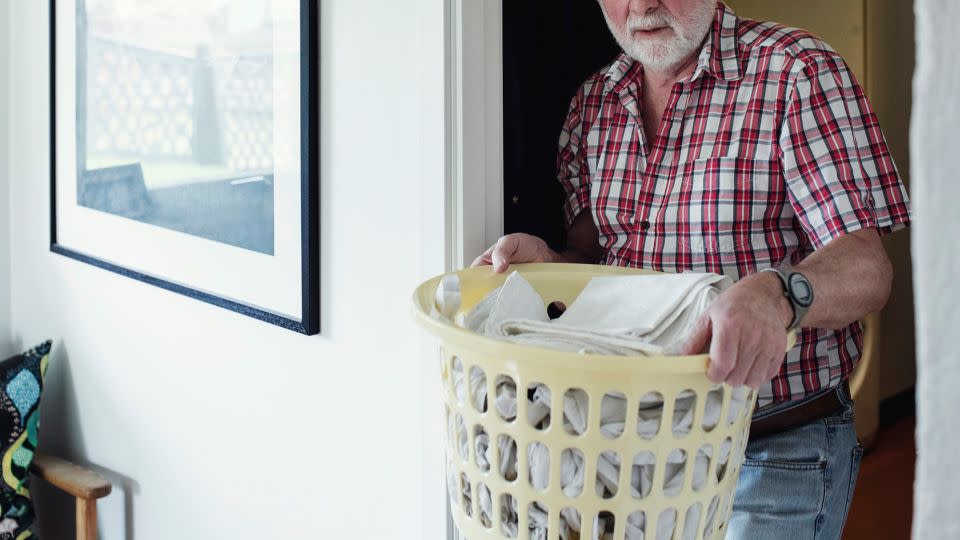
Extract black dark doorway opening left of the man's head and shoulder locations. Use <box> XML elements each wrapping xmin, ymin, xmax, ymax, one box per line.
<box><xmin>503</xmin><ymin>0</ymin><xmax>620</xmax><ymax>249</ymax></box>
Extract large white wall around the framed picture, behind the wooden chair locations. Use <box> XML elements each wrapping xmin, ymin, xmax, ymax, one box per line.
<box><xmin>4</xmin><ymin>0</ymin><xmax>446</xmax><ymax>540</ymax></box>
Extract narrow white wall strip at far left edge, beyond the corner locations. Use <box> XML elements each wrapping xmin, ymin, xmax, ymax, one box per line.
<box><xmin>0</xmin><ymin>2</ymin><xmax>12</xmax><ymax>358</ymax></box>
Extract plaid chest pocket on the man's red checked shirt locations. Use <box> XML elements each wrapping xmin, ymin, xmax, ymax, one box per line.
<box><xmin>671</xmin><ymin>156</ymin><xmax>769</xmax><ymax>264</ymax></box>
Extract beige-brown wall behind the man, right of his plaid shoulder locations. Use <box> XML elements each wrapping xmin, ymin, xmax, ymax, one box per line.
<box><xmin>727</xmin><ymin>0</ymin><xmax>916</xmax><ymax>399</ymax></box>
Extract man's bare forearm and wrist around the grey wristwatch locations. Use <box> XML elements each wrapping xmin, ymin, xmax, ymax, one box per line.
<box><xmin>747</xmin><ymin>229</ymin><xmax>893</xmax><ymax>328</ymax></box>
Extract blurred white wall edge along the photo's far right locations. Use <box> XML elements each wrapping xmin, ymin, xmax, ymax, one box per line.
<box><xmin>911</xmin><ymin>0</ymin><xmax>960</xmax><ymax>538</ymax></box>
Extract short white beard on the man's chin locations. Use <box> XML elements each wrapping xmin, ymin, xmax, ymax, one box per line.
<box><xmin>601</xmin><ymin>0</ymin><xmax>716</xmax><ymax>71</ymax></box>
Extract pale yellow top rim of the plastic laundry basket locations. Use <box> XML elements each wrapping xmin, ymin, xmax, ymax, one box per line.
<box><xmin>412</xmin><ymin>263</ymin><xmax>796</xmax><ymax>375</ymax></box>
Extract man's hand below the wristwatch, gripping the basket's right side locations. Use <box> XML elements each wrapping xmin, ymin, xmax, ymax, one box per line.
<box><xmin>681</xmin><ymin>272</ymin><xmax>793</xmax><ymax>388</ymax></box>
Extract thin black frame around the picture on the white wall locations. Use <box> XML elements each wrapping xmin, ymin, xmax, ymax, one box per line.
<box><xmin>49</xmin><ymin>0</ymin><xmax>320</xmax><ymax>335</ymax></box>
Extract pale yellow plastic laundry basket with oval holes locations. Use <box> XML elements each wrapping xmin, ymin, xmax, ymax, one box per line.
<box><xmin>414</xmin><ymin>264</ymin><xmax>784</xmax><ymax>540</ymax></box>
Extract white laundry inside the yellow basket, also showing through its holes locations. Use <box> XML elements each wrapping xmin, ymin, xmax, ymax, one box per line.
<box><xmin>436</xmin><ymin>272</ymin><xmax>749</xmax><ymax>540</ymax></box>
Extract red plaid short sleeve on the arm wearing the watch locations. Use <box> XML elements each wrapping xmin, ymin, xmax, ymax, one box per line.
<box><xmin>780</xmin><ymin>55</ymin><xmax>910</xmax><ymax>249</ymax></box>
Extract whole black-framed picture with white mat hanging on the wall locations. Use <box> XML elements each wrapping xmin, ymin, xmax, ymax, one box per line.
<box><xmin>50</xmin><ymin>0</ymin><xmax>319</xmax><ymax>334</ymax></box>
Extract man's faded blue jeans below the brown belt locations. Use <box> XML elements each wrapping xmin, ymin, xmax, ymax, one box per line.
<box><xmin>726</xmin><ymin>385</ymin><xmax>863</xmax><ymax>540</ymax></box>
